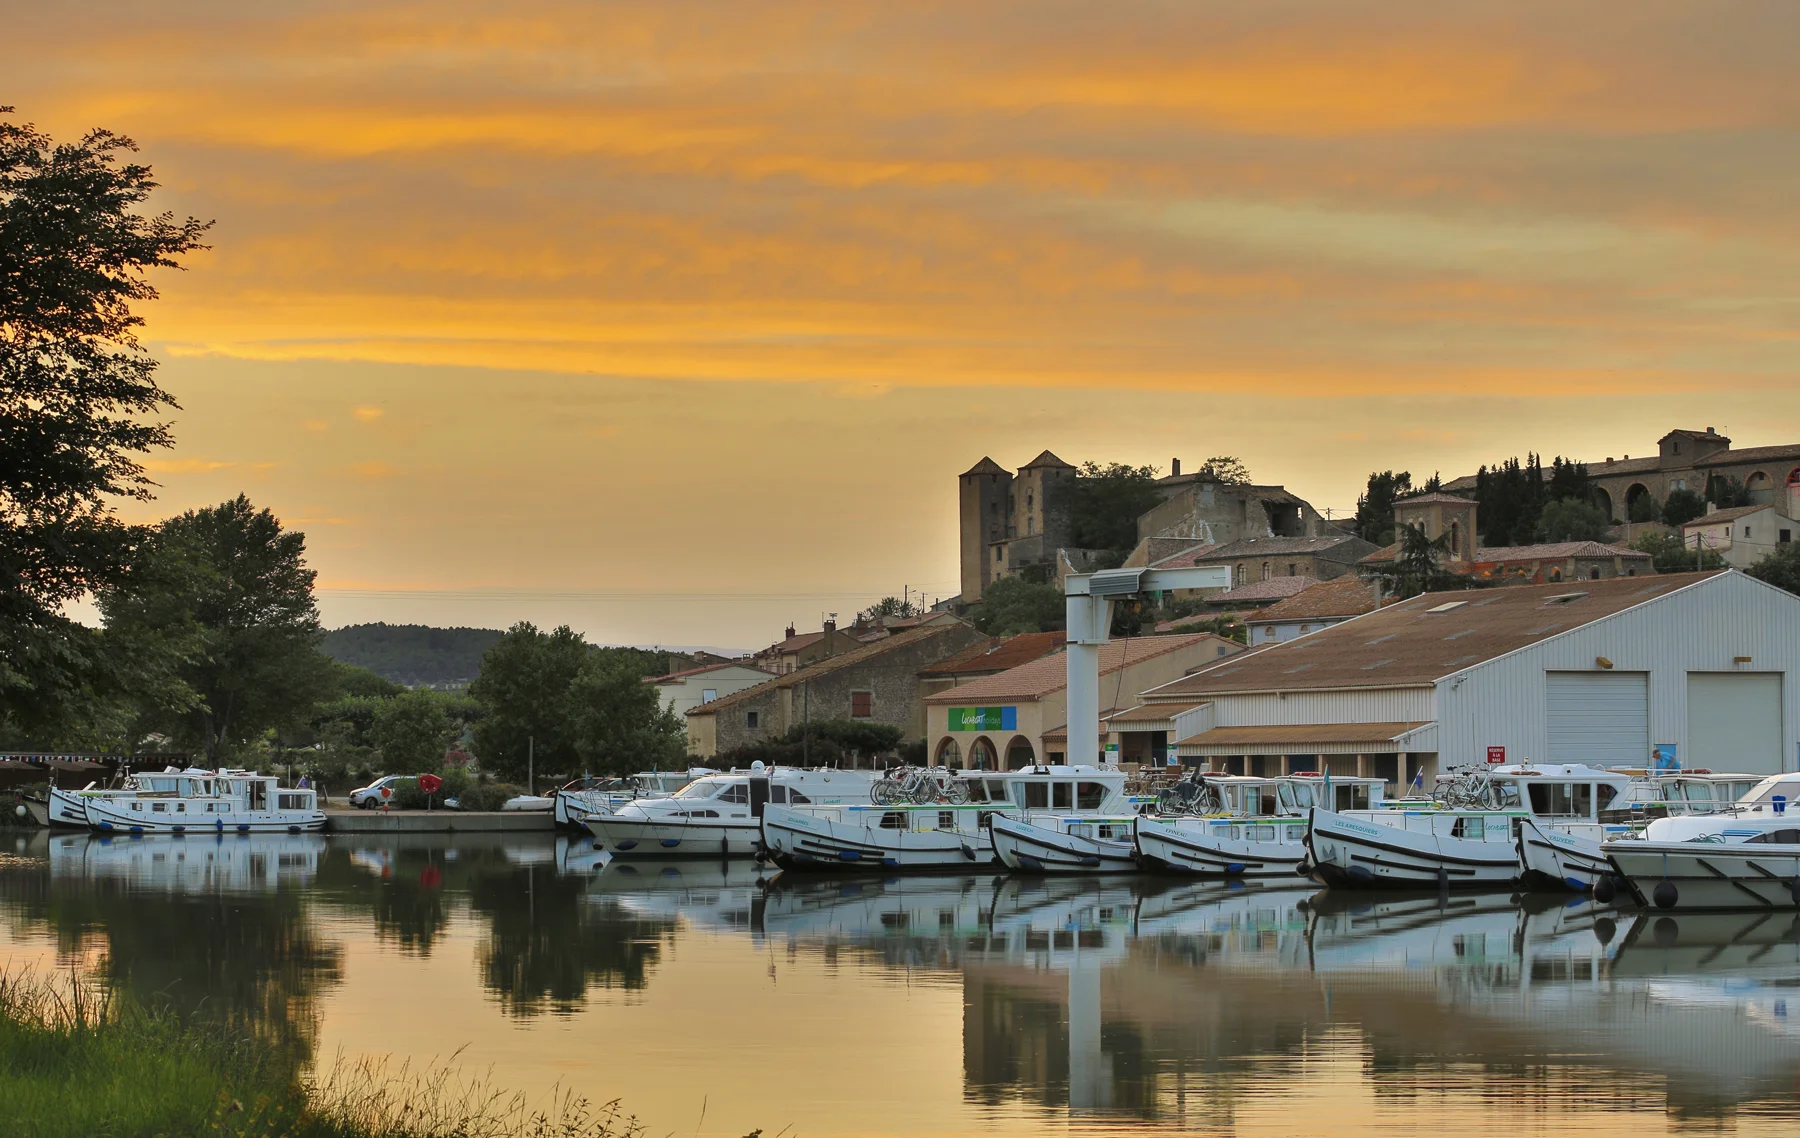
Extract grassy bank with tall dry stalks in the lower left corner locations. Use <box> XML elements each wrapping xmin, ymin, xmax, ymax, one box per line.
<box><xmin>0</xmin><ymin>976</ymin><xmax>662</xmax><ymax>1138</ymax></box>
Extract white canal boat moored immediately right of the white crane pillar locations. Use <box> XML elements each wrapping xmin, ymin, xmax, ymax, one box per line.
<box><xmin>1136</xmin><ymin>774</ymin><xmax>1386</xmax><ymax>877</ymax></box>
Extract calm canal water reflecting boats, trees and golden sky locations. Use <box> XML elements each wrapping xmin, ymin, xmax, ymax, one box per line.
<box><xmin>0</xmin><ymin>832</ymin><xmax>1800</xmax><ymax>1138</ymax></box>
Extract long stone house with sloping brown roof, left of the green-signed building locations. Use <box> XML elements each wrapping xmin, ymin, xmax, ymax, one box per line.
<box><xmin>688</xmin><ymin>619</ymin><xmax>985</xmax><ymax>758</ymax></box>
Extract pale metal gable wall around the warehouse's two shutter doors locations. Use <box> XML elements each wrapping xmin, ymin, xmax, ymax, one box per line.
<box><xmin>1436</xmin><ymin>573</ymin><xmax>1800</xmax><ymax>771</ymax></box>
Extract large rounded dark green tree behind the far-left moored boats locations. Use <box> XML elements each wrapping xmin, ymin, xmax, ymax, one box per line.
<box><xmin>99</xmin><ymin>493</ymin><xmax>335</xmax><ymax>763</ymax></box>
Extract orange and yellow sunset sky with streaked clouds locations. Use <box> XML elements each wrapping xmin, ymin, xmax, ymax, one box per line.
<box><xmin>0</xmin><ymin>0</ymin><xmax>1800</xmax><ymax>646</ymax></box>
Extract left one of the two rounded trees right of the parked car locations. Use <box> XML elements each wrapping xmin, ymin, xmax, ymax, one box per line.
<box><xmin>468</xmin><ymin>621</ymin><xmax>583</xmax><ymax>781</ymax></box>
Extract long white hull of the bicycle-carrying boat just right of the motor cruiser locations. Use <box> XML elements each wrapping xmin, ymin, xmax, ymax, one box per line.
<box><xmin>763</xmin><ymin>807</ymin><xmax>1001</xmax><ymax>873</ymax></box>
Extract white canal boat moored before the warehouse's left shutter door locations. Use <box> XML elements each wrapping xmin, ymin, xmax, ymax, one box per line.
<box><xmin>1307</xmin><ymin>763</ymin><xmax>1631</xmax><ymax>890</ymax></box>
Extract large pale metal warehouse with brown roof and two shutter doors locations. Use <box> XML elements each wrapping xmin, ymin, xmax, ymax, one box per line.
<box><xmin>1143</xmin><ymin>571</ymin><xmax>1800</xmax><ymax>785</ymax></box>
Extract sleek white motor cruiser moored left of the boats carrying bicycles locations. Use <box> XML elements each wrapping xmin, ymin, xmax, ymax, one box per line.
<box><xmin>581</xmin><ymin>762</ymin><xmax>871</xmax><ymax>857</ymax></box>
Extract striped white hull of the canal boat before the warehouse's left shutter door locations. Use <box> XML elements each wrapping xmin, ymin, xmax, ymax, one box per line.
<box><xmin>1307</xmin><ymin>807</ymin><xmax>1519</xmax><ymax>890</ymax></box>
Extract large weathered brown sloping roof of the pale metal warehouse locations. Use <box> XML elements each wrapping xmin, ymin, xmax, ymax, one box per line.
<box><xmin>1145</xmin><ymin>573</ymin><xmax>1719</xmax><ymax>702</ymax></box>
